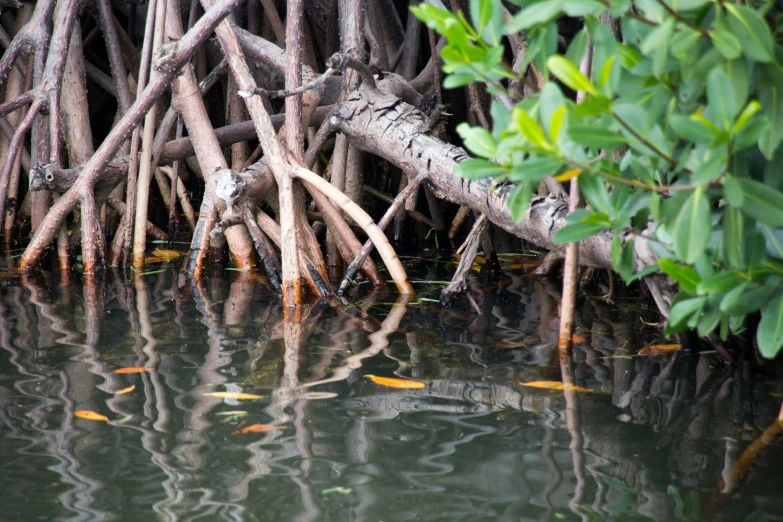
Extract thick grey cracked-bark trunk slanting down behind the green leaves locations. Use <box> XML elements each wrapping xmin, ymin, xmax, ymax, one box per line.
<box><xmin>330</xmin><ymin>82</ymin><xmax>656</xmax><ymax>269</ymax></box>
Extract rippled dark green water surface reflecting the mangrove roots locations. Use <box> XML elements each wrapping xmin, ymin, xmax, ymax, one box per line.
<box><xmin>0</xmin><ymin>271</ymin><xmax>783</xmax><ymax>521</ymax></box>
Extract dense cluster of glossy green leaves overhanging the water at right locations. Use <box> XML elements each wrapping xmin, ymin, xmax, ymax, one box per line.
<box><xmin>412</xmin><ymin>0</ymin><xmax>783</xmax><ymax>357</ymax></box>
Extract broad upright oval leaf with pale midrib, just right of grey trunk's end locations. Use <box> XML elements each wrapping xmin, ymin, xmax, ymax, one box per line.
<box><xmin>671</xmin><ymin>187</ymin><xmax>712</xmax><ymax>264</ymax></box>
